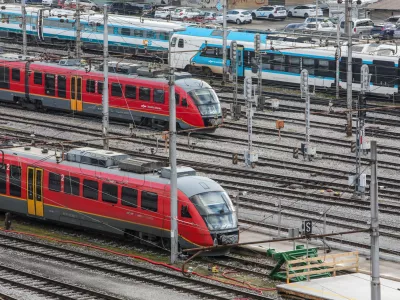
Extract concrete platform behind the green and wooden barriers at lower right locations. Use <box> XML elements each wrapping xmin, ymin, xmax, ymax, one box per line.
<box><xmin>240</xmin><ymin>230</ymin><xmax>400</xmax><ymax>282</ymax></box>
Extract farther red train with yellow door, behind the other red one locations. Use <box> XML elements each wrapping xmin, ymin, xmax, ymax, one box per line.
<box><xmin>0</xmin><ymin>54</ymin><xmax>222</xmax><ymax>130</ymax></box>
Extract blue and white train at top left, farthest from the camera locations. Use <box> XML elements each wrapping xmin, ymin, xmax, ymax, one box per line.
<box><xmin>0</xmin><ymin>5</ymin><xmax>186</xmax><ymax>54</ymax></box>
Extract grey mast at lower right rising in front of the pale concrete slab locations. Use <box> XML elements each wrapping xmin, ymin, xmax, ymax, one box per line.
<box><xmin>370</xmin><ymin>141</ymin><xmax>381</xmax><ymax>300</ymax></box>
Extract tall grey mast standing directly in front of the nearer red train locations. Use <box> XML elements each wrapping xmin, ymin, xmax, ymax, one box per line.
<box><xmin>168</xmin><ymin>32</ymin><xmax>179</xmax><ymax>264</ymax></box>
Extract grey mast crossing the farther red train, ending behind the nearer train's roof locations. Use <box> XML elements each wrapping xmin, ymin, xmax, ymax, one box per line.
<box><xmin>102</xmin><ymin>1</ymin><xmax>109</xmax><ymax>150</ymax></box>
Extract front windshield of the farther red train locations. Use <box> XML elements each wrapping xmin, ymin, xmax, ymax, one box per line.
<box><xmin>189</xmin><ymin>89</ymin><xmax>221</xmax><ymax>116</ymax></box>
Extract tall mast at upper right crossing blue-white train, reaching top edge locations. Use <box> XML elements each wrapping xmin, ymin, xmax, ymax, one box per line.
<box><xmin>346</xmin><ymin>0</ymin><xmax>353</xmax><ymax>136</ymax></box>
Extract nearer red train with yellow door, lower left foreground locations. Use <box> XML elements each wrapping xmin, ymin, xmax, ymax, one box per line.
<box><xmin>0</xmin><ymin>147</ymin><xmax>239</xmax><ymax>254</ymax></box>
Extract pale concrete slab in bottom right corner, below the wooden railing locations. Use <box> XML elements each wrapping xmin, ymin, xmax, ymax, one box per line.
<box><xmin>277</xmin><ymin>273</ymin><xmax>400</xmax><ymax>300</ymax></box>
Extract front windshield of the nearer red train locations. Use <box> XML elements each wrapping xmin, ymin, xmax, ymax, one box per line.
<box><xmin>190</xmin><ymin>192</ymin><xmax>237</xmax><ymax>230</ymax></box>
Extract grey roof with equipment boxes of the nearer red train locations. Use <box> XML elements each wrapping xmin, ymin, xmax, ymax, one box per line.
<box><xmin>3</xmin><ymin>147</ymin><xmax>224</xmax><ymax>197</ymax></box>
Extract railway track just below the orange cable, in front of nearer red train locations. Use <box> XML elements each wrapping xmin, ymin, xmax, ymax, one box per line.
<box><xmin>0</xmin><ymin>233</ymin><xmax>272</xmax><ymax>299</ymax></box>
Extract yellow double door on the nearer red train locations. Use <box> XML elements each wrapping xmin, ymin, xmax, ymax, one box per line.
<box><xmin>27</xmin><ymin>167</ymin><xmax>43</xmax><ymax>217</ymax></box>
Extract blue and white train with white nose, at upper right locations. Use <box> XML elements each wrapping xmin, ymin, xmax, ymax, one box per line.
<box><xmin>171</xmin><ymin>28</ymin><xmax>400</xmax><ymax>97</ymax></box>
